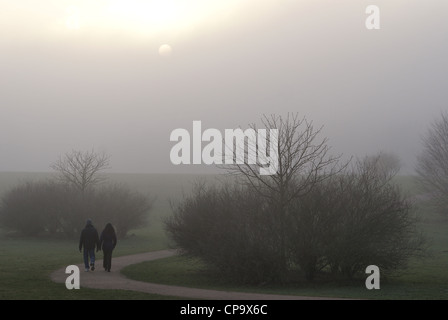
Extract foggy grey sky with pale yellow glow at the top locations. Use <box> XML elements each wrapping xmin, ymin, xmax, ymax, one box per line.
<box><xmin>0</xmin><ymin>0</ymin><xmax>448</xmax><ymax>173</ymax></box>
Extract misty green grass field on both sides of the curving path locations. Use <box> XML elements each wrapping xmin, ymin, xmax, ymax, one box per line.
<box><xmin>0</xmin><ymin>173</ymin><xmax>448</xmax><ymax>299</ymax></box>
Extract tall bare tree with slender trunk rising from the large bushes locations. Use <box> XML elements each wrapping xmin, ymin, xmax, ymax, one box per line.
<box><xmin>226</xmin><ymin>114</ymin><xmax>346</xmax><ymax>276</ymax></box>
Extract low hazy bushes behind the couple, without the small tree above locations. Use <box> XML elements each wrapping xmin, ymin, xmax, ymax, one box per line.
<box><xmin>0</xmin><ymin>181</ymin><xmax>151</xmax><ymax>237</ymax></box>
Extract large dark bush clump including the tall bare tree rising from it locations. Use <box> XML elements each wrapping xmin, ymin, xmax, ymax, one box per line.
<box><xmin>165</xmin><ymin>116</ymin><xmax>425</xmax><ymax>283</ymax></box>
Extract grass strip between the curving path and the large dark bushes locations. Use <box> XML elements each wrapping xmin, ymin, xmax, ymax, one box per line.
<box><xmin>122</xmin><ymin>252</ymin><xmax>448</xmax><ymax>300</ymax></box>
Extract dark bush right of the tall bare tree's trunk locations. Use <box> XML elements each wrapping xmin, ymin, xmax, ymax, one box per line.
<box><xmin>290</xmin><ymin>159</ymin><xmax>425</xmax><ymax>280</ymax></box>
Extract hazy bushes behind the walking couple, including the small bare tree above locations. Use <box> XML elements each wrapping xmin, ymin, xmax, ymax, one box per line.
<box><xmin>0</xmin><ymin>151</ymin><xmax>152</xmax><ymax>237</ymax></box>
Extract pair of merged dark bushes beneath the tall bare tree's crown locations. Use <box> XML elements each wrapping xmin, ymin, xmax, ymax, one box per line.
<box><xmin>165</xmin><ymin>158</ymin><xmax>424</xmax><ymax>283</ymax></box>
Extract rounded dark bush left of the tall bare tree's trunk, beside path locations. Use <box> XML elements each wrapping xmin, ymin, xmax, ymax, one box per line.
<box><xmin>165</xmin><ymin>181</ymin><xmax>279</xmax><ymax>283</ymax></box>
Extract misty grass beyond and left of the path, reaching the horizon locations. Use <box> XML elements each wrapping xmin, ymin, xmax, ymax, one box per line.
<box><xmin>0</xmin><ymin>173</ymin><xmax>196</xmax><ymax>300</ymax></box>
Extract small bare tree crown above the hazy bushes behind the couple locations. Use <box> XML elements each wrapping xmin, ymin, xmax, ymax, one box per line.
<box><xmin>50</xmin><ymin>150</ymin><xmax>109</xmax><ymax>193</ymax></box>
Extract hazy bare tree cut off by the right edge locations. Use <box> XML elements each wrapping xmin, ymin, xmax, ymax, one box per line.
<box><xmin>416</xmin><ymin>112</ymin><xmax>448</xmax><ymax>214</ymax></box>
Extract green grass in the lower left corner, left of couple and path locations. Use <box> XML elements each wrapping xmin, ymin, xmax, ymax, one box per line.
<box><xmin>0</xmin><ymin>238</ymin><xmax>182</xmax><ymax>300</ymax></box>
